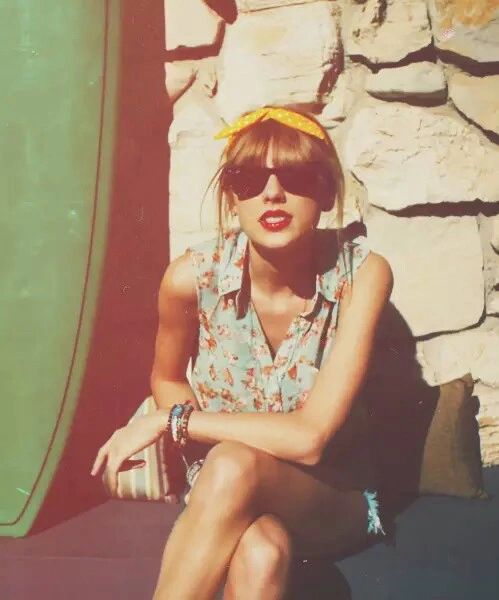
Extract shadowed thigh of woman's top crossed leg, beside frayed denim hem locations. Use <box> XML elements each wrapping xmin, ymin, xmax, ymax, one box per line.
<box><xmin>186</xmin><ymin>442</ymin><xmax>371</xmax><ymax>558</ymax></box>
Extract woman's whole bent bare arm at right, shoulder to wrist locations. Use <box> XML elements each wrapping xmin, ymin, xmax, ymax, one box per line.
<box><xmin>188</xmin><ymin>253</ymin><xmax>393</xmax><ymax>465</ymax></box>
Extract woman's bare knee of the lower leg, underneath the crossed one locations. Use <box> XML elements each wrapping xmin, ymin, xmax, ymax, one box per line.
<box><xmin>234</xmin><ymin>514</ymin><xmax>293</xmax><ymax>584</ymax></box>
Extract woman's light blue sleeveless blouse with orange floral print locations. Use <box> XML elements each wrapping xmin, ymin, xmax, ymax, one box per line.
<box><xmin>188</xmin><ymin>229</ymin><xmax>378</xmax><ymax>488</ymax></box>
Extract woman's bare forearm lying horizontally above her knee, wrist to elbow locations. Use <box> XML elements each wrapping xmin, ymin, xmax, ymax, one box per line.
<box><xmin>188</xmin><ymin>410</ymin><xmax>319</xmax><ymax>465</ymax></box>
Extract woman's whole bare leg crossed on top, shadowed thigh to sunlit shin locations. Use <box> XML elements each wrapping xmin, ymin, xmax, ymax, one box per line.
<box><xmin>154</xmin><ymin>442</ymin><xmax>367</xmax><ymax>600</ymax></box>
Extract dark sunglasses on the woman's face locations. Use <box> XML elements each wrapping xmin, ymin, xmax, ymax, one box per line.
<box><xmin>221</xmin><ymin>163</ymin><xmax>334</xmax><ymax>200</ymax></box>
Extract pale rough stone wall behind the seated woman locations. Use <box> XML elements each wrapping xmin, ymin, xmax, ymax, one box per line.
<box><xmin>165</xmin><ymin>0</ymin><xmax>499</xmax><ymax>464</ymax></box>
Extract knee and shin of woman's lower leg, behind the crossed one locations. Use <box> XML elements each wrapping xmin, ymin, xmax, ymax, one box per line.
<box><xmin>224</xmin><ymin>514</ymin><xmax>292</xmax><ymax>600</ymax></box>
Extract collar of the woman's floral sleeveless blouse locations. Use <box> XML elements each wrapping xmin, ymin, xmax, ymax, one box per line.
<box><xmin>218</xmin><ymin>229</ymin><xmax>339</xmax><ymax>302</ymax></box>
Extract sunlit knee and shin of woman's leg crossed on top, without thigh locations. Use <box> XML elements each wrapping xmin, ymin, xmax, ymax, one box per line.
<box><xmin>154</xmin><ymin>443</ymin><xmax>258</xmax><ymax>600</ymax></box>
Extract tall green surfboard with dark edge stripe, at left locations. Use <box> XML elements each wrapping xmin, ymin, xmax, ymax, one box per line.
<box><xmin>0</xmin><ymin>0</ymin><xmax>120</xmax><ymax>535</ymax></box>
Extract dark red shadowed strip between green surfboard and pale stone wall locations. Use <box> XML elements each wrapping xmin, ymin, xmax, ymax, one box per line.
<box><xmin>32</xmin><ymin>0</ymin><xmax>171</xmax><ymax>532</ymax></box>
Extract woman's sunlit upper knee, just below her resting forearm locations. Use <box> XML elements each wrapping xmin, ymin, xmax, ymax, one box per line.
<box><xmin>193</xmin><ymin>442</ymin><xmax>260</xmax><ymax>500</ymax></box>
